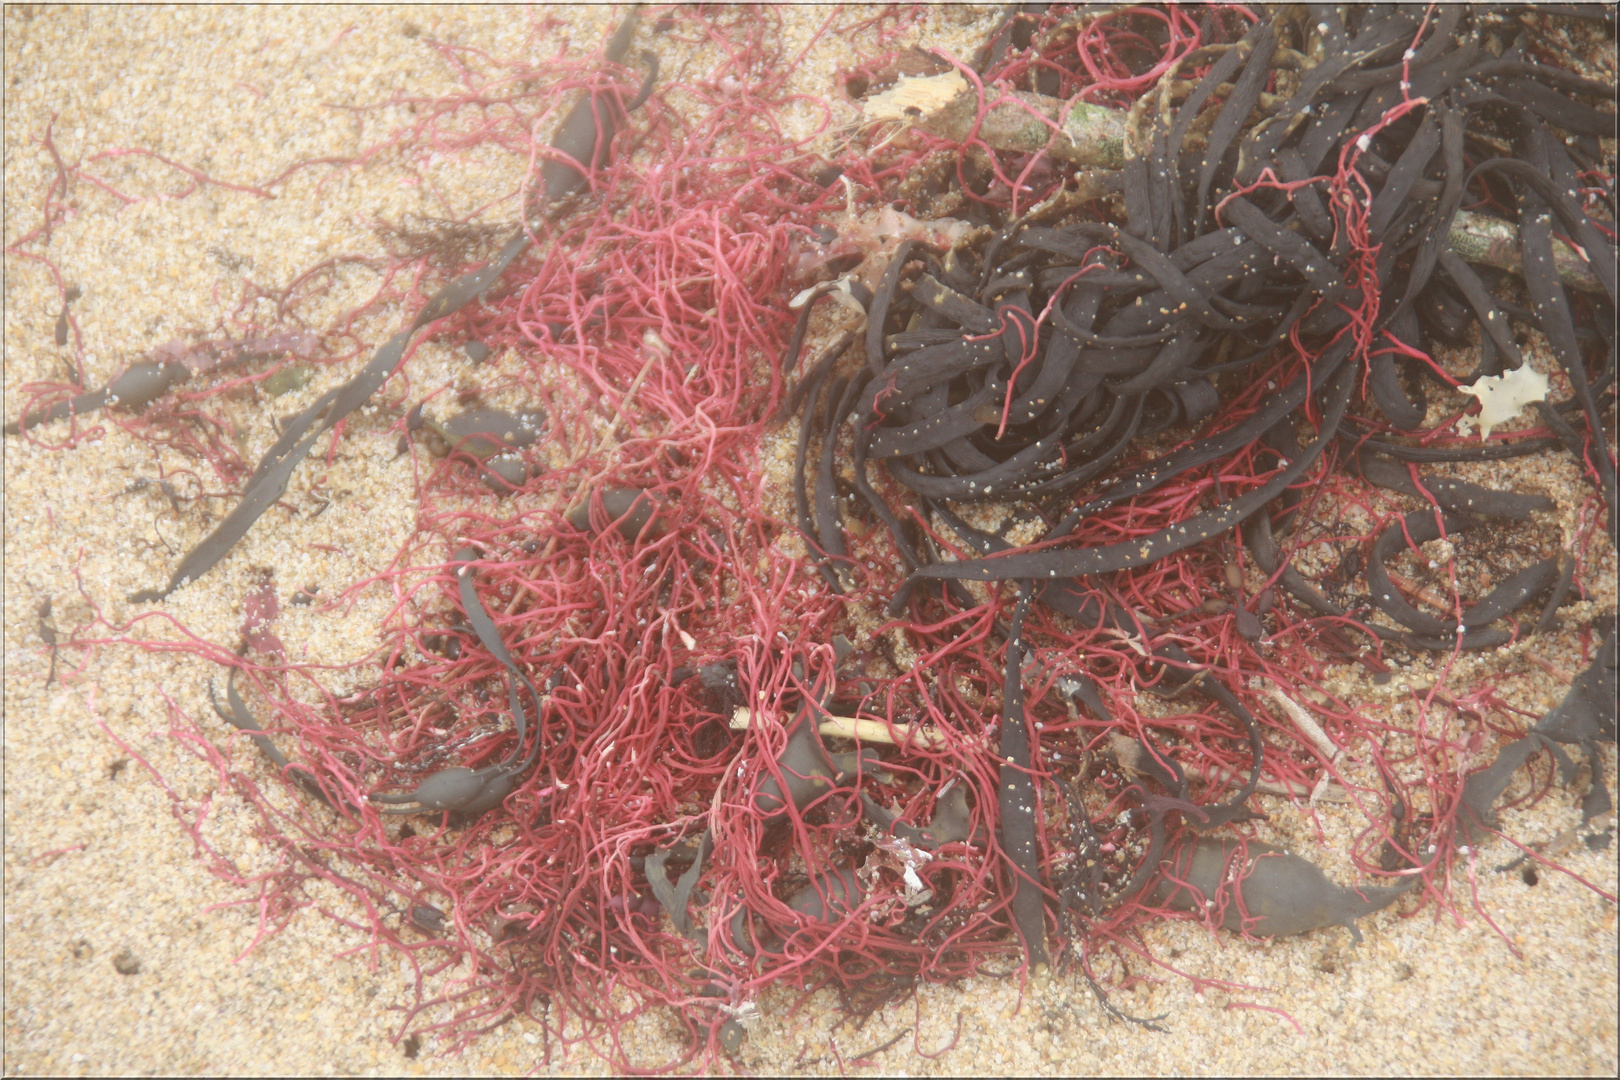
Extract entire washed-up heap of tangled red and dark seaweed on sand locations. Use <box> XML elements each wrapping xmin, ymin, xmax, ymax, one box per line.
<box><xmin>18</xmin><ymin>5</ymin><xmax>1615</xmax><ymax>1064</ymax></box>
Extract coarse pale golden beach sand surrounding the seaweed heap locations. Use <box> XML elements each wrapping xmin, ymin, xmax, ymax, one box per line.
<box><xmin>3</xmin><ymin>6</ymin><xmax>1620</xmax><ymax>1075</ymax></box>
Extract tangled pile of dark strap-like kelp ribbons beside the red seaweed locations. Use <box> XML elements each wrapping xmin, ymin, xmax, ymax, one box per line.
<box><xmin>784</xmin><ymin>5</ymin><xmax>1615</xmax><ymax>957</ymax></box>
